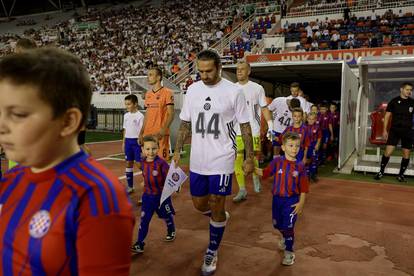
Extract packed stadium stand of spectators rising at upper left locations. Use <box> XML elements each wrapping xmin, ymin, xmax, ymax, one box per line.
<box><xmin>0</xmin><ymin>0</ymin><xmax>243</xmax><ymax>91</ymax></box>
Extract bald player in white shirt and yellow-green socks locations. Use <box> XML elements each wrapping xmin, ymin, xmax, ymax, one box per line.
<box><xmin>233</xmin><ymin>62</ymin><xmax>273</xmax><ymax>202</ymax></box>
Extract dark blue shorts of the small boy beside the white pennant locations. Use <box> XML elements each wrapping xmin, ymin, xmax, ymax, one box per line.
<box><xmin>141</xmin><ymin>193</ymin><xmax>175</xmax><ymax>218</ymax></box>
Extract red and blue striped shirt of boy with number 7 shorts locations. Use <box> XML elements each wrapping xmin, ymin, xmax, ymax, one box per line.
<box><xmin>263</xmin><ymin>156</ymin><xmax>309</xmax><ymax>197</ymax></box>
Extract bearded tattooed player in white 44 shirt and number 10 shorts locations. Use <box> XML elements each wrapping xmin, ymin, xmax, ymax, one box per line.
<box><xmin>173</xmin><ymin>50</ymin><xmax>254</xmax><ymax>275</ymax></box>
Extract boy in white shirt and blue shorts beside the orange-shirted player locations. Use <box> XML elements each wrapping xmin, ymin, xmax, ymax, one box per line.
<box><xmin>122</xmin><ymin>94</ymin><xmax>144</xmax><ymax>196</ymax></box>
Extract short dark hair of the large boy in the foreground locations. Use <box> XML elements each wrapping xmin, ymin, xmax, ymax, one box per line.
<box><xmin>0</xmin><ymin>47</ymin><xmax>92</xmax><ymax>128</ymax></box>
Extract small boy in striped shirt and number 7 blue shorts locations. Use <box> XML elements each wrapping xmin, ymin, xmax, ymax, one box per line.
<box><xmin>255</xmin><ymin>132</ymin><xmax>309</xmax><ymax>265</ymax></box>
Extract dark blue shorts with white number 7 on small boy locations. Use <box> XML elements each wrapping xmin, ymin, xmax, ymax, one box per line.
<box><xmin>272</xmin><ymin>195</ymin><xmax>299</xmax><ymax>230</ymax></box>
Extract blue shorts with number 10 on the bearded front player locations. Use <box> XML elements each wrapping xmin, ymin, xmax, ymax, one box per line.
<box><xmin>190</xmin><ymin>171</ymin><xmax>233</xmax><ymax>197</ymax></box>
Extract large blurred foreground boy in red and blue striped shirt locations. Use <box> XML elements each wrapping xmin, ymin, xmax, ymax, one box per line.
<box><xmin>0</xmin><ymin>47</ymin><xmax>135</xmax><ymax>276</ymax></box>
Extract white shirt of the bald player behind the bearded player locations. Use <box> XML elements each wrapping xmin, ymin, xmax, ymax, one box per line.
<box><xmin>235</xmin><ymin>81</ymin><xmax>267</xmax><ymax>136</ymax></box>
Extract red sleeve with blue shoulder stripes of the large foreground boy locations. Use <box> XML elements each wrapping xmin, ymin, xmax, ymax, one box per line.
<box><xmin>76</xmin><ymin>162</ymin><xmax>135</xmax><ymax>275</ymax></box>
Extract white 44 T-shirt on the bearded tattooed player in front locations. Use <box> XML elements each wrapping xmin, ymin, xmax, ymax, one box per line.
<box><xmin>180</xmin><ymin>79</ymin><xmax>249</xmax><ymax>175</ymax></box>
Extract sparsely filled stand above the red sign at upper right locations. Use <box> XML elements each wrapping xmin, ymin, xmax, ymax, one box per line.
<box><xmin>279</xmin><ymin>5</ymin><xmax>414</xmax><ymax>51</ymax></box>
